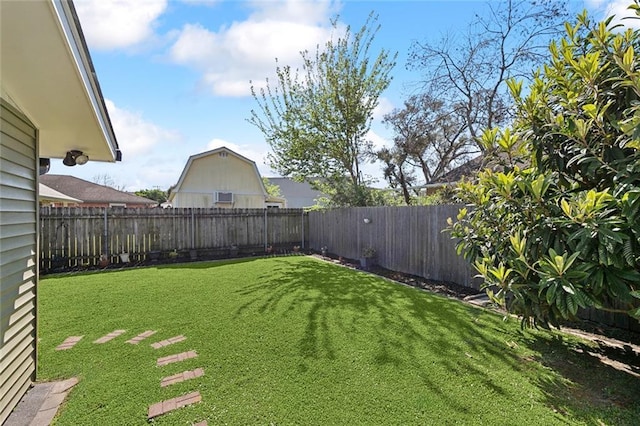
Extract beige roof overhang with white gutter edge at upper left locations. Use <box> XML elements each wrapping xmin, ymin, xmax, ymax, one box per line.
<box><xmin>0</xmin><ymin>0</ymin><xmax>121</xmax><ymax>162</ymax></box>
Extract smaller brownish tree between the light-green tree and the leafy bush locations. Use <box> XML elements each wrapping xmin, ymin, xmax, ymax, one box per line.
<box><xmin>379</xmin><ymin>94</ymin><xmax>474</xmax><ymax>198</ymax></box>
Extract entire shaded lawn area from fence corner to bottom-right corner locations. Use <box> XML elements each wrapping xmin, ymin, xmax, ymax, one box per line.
<box><xmin>229</xmin><ymin>255</ymin><xmax>640</xmax><ymax>425</ymax></box>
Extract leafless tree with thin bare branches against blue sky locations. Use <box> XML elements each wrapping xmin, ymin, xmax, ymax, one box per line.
<box><xmin>409</xmin><ymin>0</ymin><xmax>570</xmax><ymax>148</ymax></box>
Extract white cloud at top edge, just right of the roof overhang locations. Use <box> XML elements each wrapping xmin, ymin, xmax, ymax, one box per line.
<box><xmin>75</xmin><ymin>0</ymin><xmax>168</xmax><ymax>50</ymax></box>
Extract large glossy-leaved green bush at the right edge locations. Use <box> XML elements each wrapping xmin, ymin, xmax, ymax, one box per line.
<box><xmin>450</xmin><ymin>5</ymin><xmax>640</xmax><ymax>326</ymax></box>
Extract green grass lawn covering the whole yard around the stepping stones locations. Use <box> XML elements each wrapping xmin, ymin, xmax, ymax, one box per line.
<box><xmin>38</xmin><ymin>256</ymin><xmax>640</xmax><ymax>425</ymax></box>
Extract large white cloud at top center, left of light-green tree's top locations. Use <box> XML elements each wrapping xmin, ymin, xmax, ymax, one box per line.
<box><xmin>169</xmin><ymin>0</ymin><xmax>337</xmax><ymax>96</ymax></box>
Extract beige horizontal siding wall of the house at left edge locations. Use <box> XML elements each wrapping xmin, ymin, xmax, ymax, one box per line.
<box><xmin>0</xmin><ymin>100</ymin><xmax>38</xmax><ymax>424</ymax></box>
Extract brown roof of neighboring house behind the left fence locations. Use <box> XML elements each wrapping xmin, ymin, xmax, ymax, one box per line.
<box><xmin>40</xmin><ymin>175</ymin><xmax>158</xmax><ymax>206</ymax></box>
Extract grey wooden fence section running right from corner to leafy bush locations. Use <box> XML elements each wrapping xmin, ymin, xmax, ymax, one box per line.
<box><xmin>309</xmin><ymin>205</ymin><xmax>480</xmax><ymax>288</ymax></box>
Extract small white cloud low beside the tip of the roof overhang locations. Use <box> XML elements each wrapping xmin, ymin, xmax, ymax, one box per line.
<box><xmin>105</xmin><ymin>99</ymin><xmax>178</xmax><ymax>159</ymax></box>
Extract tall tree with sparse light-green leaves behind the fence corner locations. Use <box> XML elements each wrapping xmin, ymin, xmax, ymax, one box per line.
<box><xmin>249</xmin><ymin>15</ymin><xmax>396</xmax><ymax>205</ymax></box>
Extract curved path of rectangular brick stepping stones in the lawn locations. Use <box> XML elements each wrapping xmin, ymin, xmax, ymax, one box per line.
<box><xmin>56</xmin><ymin>330</ymin><xmax>207</xmax><ymax>426</ymax></box>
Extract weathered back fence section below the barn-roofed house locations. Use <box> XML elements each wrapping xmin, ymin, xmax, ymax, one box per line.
<box><xmin>40</xmin><ymin>207</ymin><xmax>308</xmax><ymax>271</ymax></box>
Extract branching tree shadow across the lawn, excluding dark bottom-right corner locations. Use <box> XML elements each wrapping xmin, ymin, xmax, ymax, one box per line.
<box><xmin>231</xmin><ymin>260</ymin><xmax>556</xmax><ymax>413</ymax></box>
